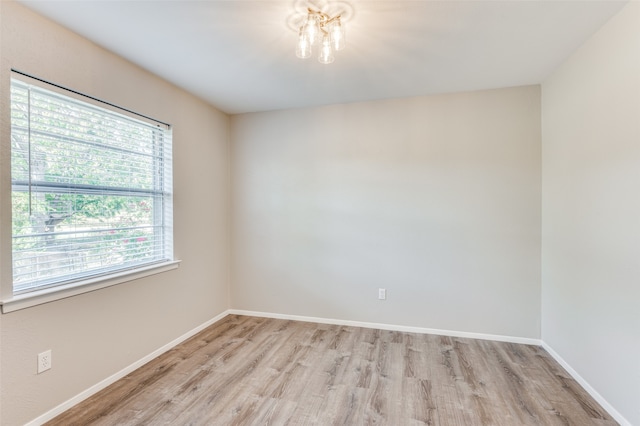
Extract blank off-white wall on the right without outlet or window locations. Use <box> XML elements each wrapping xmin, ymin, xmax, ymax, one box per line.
<box><xmin>542</xmin><ymin>2</ymin><xmax>640</xmax><ymax>425</ymax></box>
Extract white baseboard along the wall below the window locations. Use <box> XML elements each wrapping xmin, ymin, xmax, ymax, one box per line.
<box><xmin>25</xmin><ymin>311</ymin><xmax>234</xmax><ymax>426</ymax></box>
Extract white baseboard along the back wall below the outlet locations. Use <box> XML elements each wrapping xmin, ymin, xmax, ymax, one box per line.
<box><xmin>228</xmin><ymin>309</ymin><xmax>542</xmax><ymax>346</ymax></box>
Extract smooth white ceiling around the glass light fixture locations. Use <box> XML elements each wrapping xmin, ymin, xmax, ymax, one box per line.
<box><xmin>21</xmin><ymin>0</ymin><xmax>625</xmax><ymax>114</ymax></box>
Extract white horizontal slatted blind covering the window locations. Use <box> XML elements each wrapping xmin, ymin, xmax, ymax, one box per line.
<box><xmin>11</xmin><ymin>79</ymin><xmax>173</xmax><ymax>295</ymax></box>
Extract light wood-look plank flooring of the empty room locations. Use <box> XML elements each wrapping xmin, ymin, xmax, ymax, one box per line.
<box><xmin>49</xmin><ymin>315</ymin><xmax>617</xmax><ymax>426</ymax></box>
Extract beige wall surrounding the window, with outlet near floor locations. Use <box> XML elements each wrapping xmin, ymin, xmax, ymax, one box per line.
<box><xmin>0</xmin><ymin>1</ymin><xmax>229</xmax><ymax>426</ymax></box>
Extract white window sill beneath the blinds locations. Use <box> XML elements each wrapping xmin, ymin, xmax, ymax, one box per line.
<box><xmin>0</xmin><ymin>260</ymin><xmax>180</xmax><ymax>314</ymax></box>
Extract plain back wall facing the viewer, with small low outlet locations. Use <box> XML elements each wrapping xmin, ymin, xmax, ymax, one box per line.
<box><xmin>231</xmin><ymin>86</ymin><xmax>541</xmax><ymax>338</ymax></box>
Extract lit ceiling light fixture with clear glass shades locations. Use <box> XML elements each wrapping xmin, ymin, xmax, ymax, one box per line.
<box><xmin>296</xmin><ymin>8</ymin><xmax>345</xmax><ymax>64</ymax></box>
